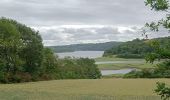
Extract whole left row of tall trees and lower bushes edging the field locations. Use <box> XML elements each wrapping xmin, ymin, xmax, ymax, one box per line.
<box><xmin>0</xmin><ymin>18</ymin><xmax>101</xmax><ymax>83</ymax></box>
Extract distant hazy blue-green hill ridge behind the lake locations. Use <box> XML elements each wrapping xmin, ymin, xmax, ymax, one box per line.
<box><xmin>48</xmin><ymin>42</ymin><xmax>122</xmax><ymax>53</ymax></box>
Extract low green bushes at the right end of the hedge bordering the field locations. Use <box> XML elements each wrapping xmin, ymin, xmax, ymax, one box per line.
<box><xmin>58</xmin><ymin>58</ymin><xmax>101</xmax><ymax>79</ymax></box>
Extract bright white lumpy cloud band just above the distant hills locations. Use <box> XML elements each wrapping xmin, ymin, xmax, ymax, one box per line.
<box><xmin>36</xmin><ymin>25</ymin><xmax>140</xmax><ymax>45</ymax></box>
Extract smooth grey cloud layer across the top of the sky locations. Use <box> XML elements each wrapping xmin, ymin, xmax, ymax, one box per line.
<box><xmin>0</xmin><ymin>0</ymin><xmax>165</xmax><ymax>26</ymax></box>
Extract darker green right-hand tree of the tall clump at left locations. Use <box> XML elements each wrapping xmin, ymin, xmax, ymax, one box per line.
<box><xmin>8</xmin><ymin>20</ymin><xmax>43</xmax><ymax>78</ymax></box>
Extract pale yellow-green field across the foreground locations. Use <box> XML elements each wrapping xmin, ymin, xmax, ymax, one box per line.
<box><xmin>0</xmin><ymin>79</ymin><xmax>170</xmax><ymax>100</ymax></box>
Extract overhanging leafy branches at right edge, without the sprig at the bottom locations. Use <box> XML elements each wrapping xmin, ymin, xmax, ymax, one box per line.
<box><xmin>144</xmin><ymin>0</ymin><xmax>170</xmax><ymax>68</ymax></box>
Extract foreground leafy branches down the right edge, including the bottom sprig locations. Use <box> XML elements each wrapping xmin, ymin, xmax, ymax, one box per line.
<box><xmin>144</xmin><ymin>0</ymin><xmax>170</xmax><ymax>100</ymax></box>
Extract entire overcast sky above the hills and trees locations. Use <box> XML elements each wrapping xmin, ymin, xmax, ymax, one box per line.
<box><xmin>0</xmin><ymin>0</ymin><xmax>169</xmax><ymax>46</ymax></box>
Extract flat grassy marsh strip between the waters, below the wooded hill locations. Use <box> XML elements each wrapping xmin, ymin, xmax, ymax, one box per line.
<box><xmin>95</xmin><ymin>57</ymin><xmax>158</xmax><ymax>70</ymax></box>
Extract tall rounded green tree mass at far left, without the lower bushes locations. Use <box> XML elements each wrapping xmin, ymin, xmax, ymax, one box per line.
<box><xmin>0</xmin><ymin>18</ymin><xmax>43</xmax><ymax>82</ymax></box>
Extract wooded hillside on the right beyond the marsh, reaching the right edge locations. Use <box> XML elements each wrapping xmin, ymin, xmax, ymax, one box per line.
<box><xmin>103</xmin><ymin>37</ymin><xmax>170</xmax><ymax>58</ymax></box>
